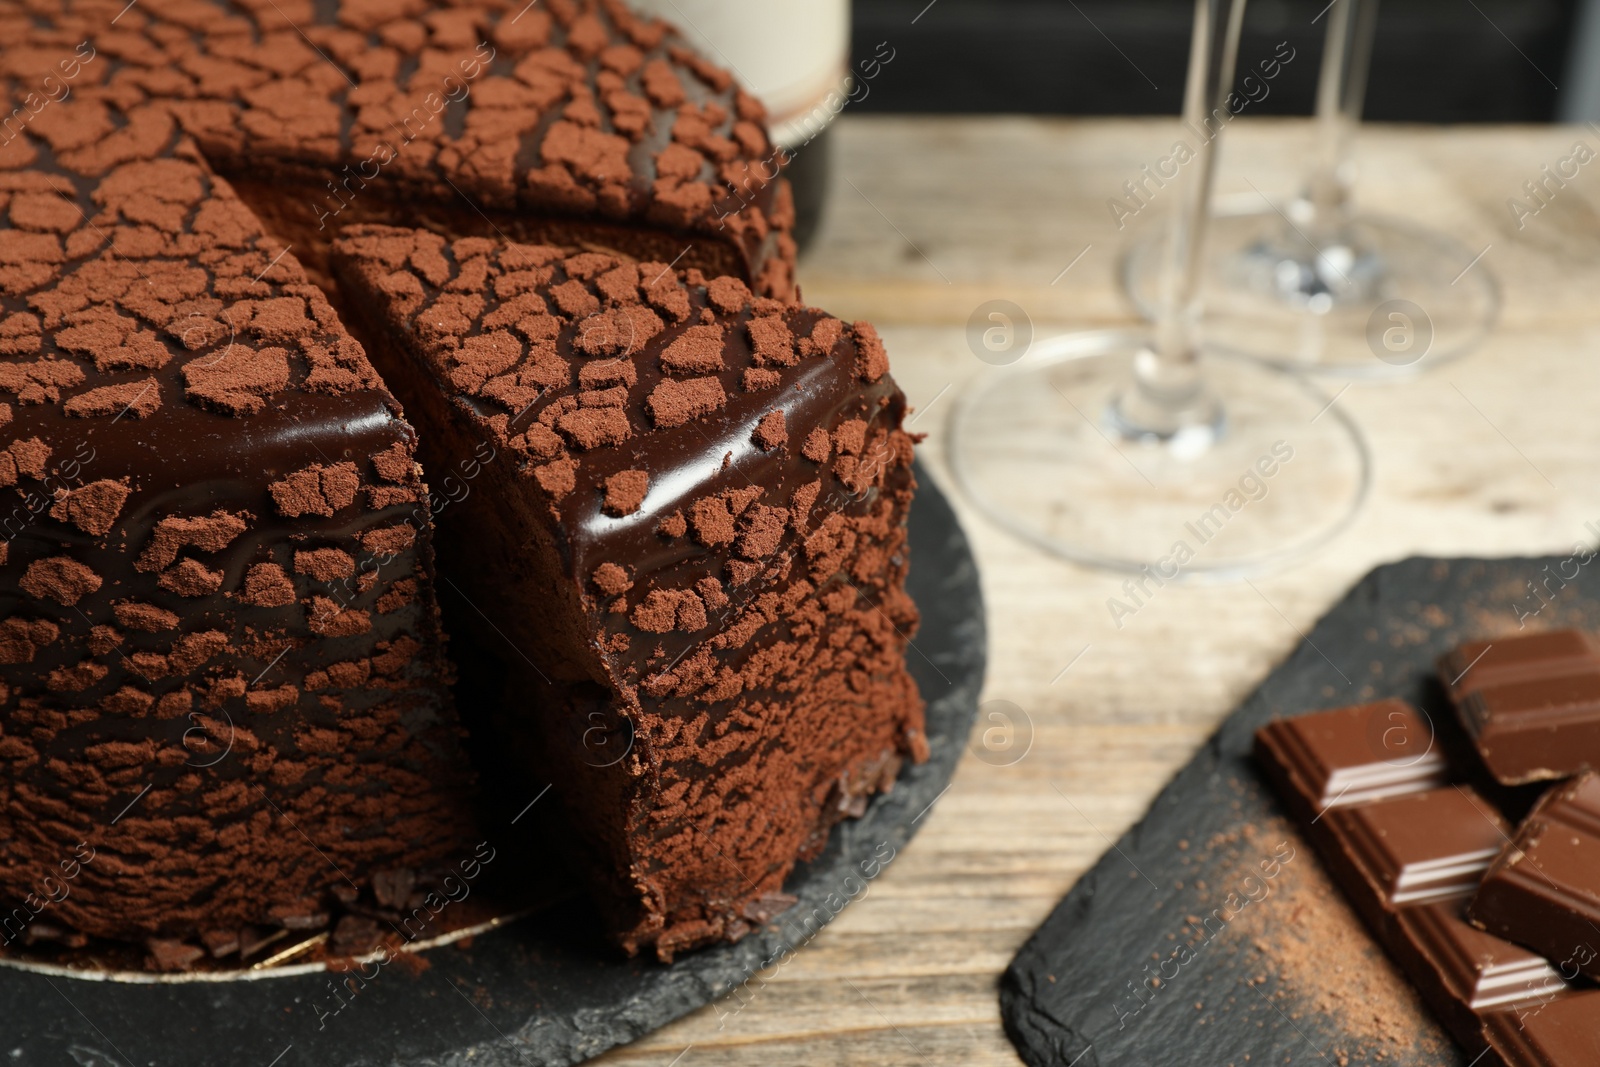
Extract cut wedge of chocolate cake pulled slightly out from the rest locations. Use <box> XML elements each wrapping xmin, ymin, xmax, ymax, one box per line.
<box><xmin>333</xmin><ymin>227</ymin><xmax>926</xmax><ymax>960</ymax></box>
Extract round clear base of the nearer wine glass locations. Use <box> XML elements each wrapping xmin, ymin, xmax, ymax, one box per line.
<box><xmin>949</xmin><ymin>333</ymin><xmax>1371</xmax><ymax>579</ymax></box>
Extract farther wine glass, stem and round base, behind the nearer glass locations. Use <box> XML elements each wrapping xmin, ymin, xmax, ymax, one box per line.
<box><xmin>1123</xmin><ymin>0</ymin><xmax>1499</xmax><ymax>378</ymax></box>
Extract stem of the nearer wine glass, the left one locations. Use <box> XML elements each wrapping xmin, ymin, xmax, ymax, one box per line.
<box><xmin>1114</xmin><ymin>0</ymin><xmax>1241</xmax><ymax>437</ymax></box>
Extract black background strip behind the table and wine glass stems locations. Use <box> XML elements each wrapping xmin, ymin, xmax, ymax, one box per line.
<box><xmin>850</xmin><ymin>0</ymin><xmax>1578</xmax><ymax>122</ymax></box>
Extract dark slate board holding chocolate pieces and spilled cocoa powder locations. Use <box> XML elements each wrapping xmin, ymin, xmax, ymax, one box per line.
<box><xmin>1000</xmin><ymin>555</ymin><xmax>1600</xmax><ymax>1067</ymax></box>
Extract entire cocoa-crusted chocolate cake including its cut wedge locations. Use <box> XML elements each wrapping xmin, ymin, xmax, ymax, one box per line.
<box><xmin>0</xmin><ymin>0</ymin><xmax>925</xmax><ymax>968</ymax></box>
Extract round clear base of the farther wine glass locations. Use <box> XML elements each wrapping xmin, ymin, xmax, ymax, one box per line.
<box><xmin>1123</xmin><ymin>197</ymin><xmax>1499</xmax><ymax>378</ymax></box>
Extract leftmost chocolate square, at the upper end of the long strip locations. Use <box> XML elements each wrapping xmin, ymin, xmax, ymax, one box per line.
<box><xmin>1256</xmin><ymin>701</ymin><xmax>1448</xmax><ymax>822</ymax></box>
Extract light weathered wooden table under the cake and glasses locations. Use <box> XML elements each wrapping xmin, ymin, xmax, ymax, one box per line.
<box><xmin>597</xmin><ymin>118</ymin><xmax>1600</xmax><ymax>1067</ymax></box>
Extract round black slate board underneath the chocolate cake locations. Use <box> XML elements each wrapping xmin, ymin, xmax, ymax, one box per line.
<box><xmin>0</xmin><ymin>472</ymin><xmax>986</xmax><ymax>1067</ymax></box>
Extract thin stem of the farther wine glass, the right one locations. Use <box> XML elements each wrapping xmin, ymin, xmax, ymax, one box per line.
<box><xmin>1302</xmin><ymin>0</ymin><xmax>1378</xmax><ymax>239</ymax></box>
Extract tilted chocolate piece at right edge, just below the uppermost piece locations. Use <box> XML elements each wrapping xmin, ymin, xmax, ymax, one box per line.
<box><xmin>1469</xmin><ymin>774</ymin><xmax>1600</xmax><ymax>979</ymax></box>
